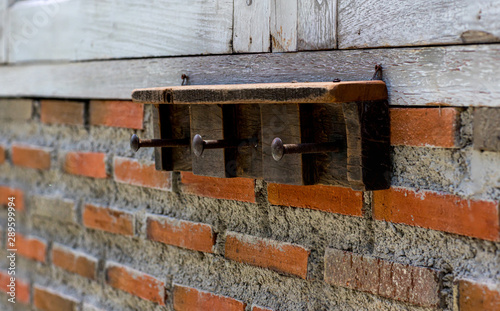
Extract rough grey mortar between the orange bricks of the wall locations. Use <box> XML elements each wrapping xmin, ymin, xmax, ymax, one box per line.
<box><xmin>0</xmin><ymin>106</ymin><xmax>500</xmax><ymax>310</ymax></box>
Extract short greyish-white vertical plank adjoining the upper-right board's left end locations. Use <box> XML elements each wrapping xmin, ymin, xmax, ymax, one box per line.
<box><xmin>297</xmin><ymin>0</ymin><xmax>337</xmax><ymax>51</ymax></box>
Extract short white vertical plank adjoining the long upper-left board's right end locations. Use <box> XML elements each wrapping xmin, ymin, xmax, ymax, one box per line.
<box><xmin>233</xmin><ymin>0</ymin><xmax>271</xmax><ymax>53</ymax></box>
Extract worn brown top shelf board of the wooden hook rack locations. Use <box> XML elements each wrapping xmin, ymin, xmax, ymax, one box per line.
<box><xmin>132</xmin><ymin>81</ymin><xmax>387</xmax><ymax>105</ymax></box>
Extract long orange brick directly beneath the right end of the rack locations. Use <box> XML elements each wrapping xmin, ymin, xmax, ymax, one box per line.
<box><xmin>267</xmin><ymin>184</ymin><xmax>363</xmax><ymax>216</ymax></box>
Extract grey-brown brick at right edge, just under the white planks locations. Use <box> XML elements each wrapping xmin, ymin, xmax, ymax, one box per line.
<box><xmin>474</xmin><ymin>108</ymin><xmax>500</xmax><ymax>151</ymax></box>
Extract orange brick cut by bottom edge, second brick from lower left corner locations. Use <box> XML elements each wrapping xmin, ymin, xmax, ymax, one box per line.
<box><xmin>33</xmin><ymin>285</ymin><xmax>80</xmax><ymax>311</ymax></box>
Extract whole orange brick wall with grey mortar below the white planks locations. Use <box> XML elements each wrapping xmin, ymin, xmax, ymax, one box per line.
<box><xmin>0</xmin><ymin>99</ymin><xmax>500</xmax><ymax>311</ymax></box>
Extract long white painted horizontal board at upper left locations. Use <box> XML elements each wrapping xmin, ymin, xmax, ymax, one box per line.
<box><xmin>9</xmin><ymin>0</ymin><xmax>233</xmax><ymax>62</ymax></box>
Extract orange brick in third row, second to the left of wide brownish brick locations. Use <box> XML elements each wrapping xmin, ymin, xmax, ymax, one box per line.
<box><xmin>147</xmin><ymin>216</ymin><xmax>215</xmax><ymax>253</ymax></box>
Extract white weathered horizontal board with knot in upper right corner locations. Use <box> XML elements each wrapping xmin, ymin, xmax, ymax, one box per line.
<box><xmin>338</xmin><ymin>0</ymin><xmax>500</xmax><ymax>49</ymax></box>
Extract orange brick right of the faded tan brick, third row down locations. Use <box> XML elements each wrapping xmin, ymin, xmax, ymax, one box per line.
<box><xmin>83</xmin><ymin>204</ymin><xmax>134</xmax><ymax>236</ymax></box>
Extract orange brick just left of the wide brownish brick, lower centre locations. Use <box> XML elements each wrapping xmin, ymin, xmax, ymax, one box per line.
<box><xmin>225</xmin><ymin>232</ymin><xmax>310</xmax><ymax>279</ymax></box>
